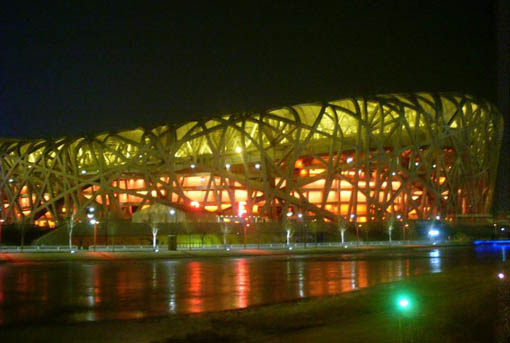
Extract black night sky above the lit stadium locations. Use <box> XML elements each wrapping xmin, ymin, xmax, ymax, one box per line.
<box><xmin>0</xmin><ymin>1</ymin><xmax>497</xmax><ymax>137</ymax></box>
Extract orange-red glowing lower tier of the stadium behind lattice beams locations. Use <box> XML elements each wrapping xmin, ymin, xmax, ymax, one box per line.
<box><xmin>9</xmin><ymin>148</ymin><xmax>482</xmax><ymax>227</ymax></box>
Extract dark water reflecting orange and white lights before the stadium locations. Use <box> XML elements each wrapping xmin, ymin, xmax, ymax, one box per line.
<box><xmin>0</xmin><ymin>246</ymin><xmax>506</xmax><ymax>325</ymax></box>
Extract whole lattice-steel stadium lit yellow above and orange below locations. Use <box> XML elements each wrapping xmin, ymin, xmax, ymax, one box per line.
<box><xmin>0</xmin><ymin>93</ymin><xmax>503</xmax><ymax>227</ymax></box>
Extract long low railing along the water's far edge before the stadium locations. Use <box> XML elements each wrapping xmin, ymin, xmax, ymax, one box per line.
<box><xmin>0</xmin><ymin>240</ymin><xmax>441</xmax><ymax>253</ymax></box>
